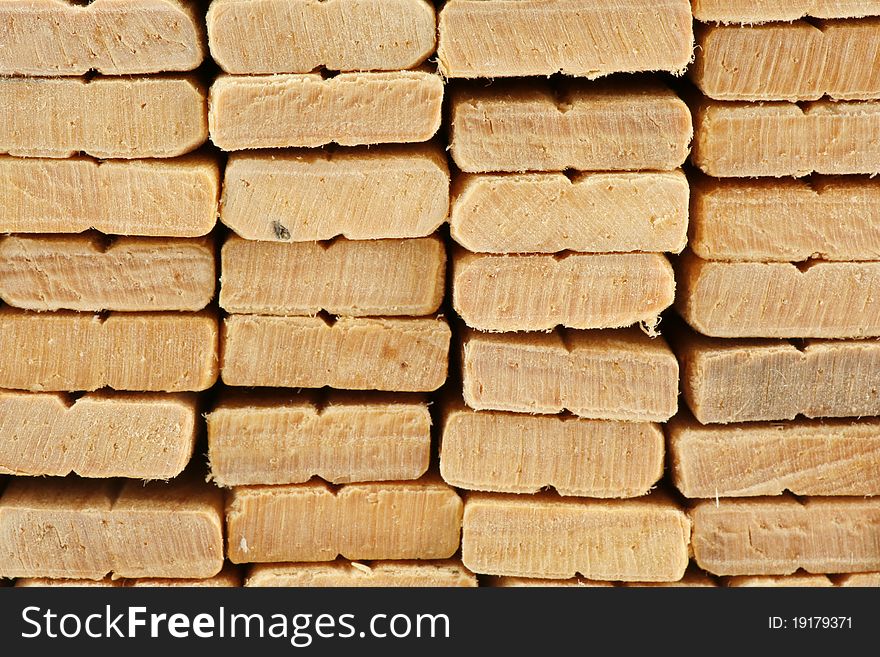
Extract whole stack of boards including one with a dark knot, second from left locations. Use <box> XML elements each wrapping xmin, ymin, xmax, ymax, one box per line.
<box><xmin>207</xmin><ymin>0</ymin><xmax>476</xmax><ymax>586</ymax></box>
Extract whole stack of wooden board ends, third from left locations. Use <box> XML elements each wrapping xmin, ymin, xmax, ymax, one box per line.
<box><xmin>438</xmin><ymin>0</ymin><xmax>692</xmax><ymax>586</ymax></box>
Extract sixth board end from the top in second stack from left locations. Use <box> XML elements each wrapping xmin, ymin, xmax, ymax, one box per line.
<box><xmin>207</xmin><ymin>392</ymin><xmax>431</xmax><ymax>486</ymax></box>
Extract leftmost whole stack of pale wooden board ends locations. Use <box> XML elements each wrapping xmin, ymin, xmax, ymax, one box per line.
<box><xmin>0</xmin><ymin>0</ymin><xmax>230</xmax><ymax>584</ymax></box>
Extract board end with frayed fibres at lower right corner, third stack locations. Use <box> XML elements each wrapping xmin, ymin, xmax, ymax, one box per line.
<box><xmin>452</xmin><ymin>249</ymin><xmax>675</xmax><ymax>331</ymax></box>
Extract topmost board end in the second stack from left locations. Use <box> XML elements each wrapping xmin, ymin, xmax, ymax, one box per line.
<box><xmin>207</xmin><ymin>0</ymin><xmax>436</xmax><ymax>74</ymax></box>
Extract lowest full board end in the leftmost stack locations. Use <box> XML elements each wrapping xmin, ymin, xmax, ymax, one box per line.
<box><xmin>0</xmin><ymin>476</ymin><xmax>223</xmax><ymax>580</ymax></box>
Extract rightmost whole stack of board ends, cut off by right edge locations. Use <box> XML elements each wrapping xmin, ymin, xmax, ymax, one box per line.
<box><xmin>669</xmin><ymin>0</ymin><xmax>880</xmax><ymax>586</ymax></box>
